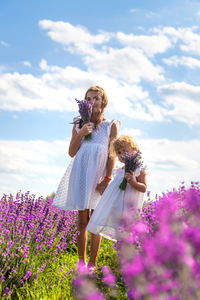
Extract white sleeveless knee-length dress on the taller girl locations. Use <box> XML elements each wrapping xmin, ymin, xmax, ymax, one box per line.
<box><xmin>52</xmin><ymin>120</ymin><xmax>117</xmax><ymax>210</ymax></box>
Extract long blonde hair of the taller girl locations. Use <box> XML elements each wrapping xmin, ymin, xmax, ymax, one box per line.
<box><xmin>85</xmin><ymin>85</ymin><xmax>108</xmax><ymax>129</ymax></box>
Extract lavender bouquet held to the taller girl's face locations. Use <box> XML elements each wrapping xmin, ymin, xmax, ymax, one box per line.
<box><xmin>75</xmin><ymin>99</ymin><xmax>93</xmax><ymax>140</ymax></box>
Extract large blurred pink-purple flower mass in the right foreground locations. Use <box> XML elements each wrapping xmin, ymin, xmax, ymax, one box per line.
<box><xmin>118</xmin><ymin>186</ymin><xmax>200</xmax><ymax>300</ymax></box>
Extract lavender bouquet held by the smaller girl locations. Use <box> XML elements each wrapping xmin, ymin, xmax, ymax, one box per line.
<box><xmin>119</xmin><ymin>151</ymin><xmax>143</xmax><ymax>191</ymax></box>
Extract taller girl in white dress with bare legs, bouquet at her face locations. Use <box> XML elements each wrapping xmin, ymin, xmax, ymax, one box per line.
<box><xmin>53</xmin><ymin>86</ymin><xmax>119</xmax><ymax>268</ymax></box>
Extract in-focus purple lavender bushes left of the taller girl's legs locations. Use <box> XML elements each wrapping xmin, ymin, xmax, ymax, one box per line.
<box><xmin>0</xmin><ymin>192</ymin><xmax>78</xmax><ymax>298</ymax></box>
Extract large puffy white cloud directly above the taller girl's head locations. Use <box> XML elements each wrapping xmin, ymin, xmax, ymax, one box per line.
<box><xmin>85</xmin><ymin>47</ymin><xmax>164</xmax><ymax>83</ymax></box>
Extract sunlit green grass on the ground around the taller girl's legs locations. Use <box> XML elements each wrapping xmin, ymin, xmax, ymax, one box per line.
<box><xmin>12</xmin><ymin>238</ymin><xmax>128</xmax><ymax>300</ymax></box>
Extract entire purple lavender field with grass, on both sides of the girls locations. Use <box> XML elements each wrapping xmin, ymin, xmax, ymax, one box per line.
<box><xmin>0</xmin><ymin>182</ymin><xmax>200</xmax><ymax>300</ymax></box>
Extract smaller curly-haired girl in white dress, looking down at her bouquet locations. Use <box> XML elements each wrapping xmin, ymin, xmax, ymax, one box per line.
<box><xmin>87</xmin><ymin>135</ymin><xmax>147</xmax><ymax>241</ymax></box>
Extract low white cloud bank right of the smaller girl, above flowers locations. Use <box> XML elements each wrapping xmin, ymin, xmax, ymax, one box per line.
<box><xmin>137</xmin><ymin>137</ymin><xmax>200</xmax><ymax>198</ymax></box>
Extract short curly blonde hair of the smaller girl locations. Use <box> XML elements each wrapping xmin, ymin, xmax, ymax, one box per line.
<box><xmin>109</xmin><ymin>135</ymin><xmax>139</xmax><ymax>157</ymax></box>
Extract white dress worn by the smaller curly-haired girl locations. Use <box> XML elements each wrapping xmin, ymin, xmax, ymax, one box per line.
<box><xmin>86</xmin><ymin>168</ymin><xmax>144</xmax><ymax>241</ymax></box>
